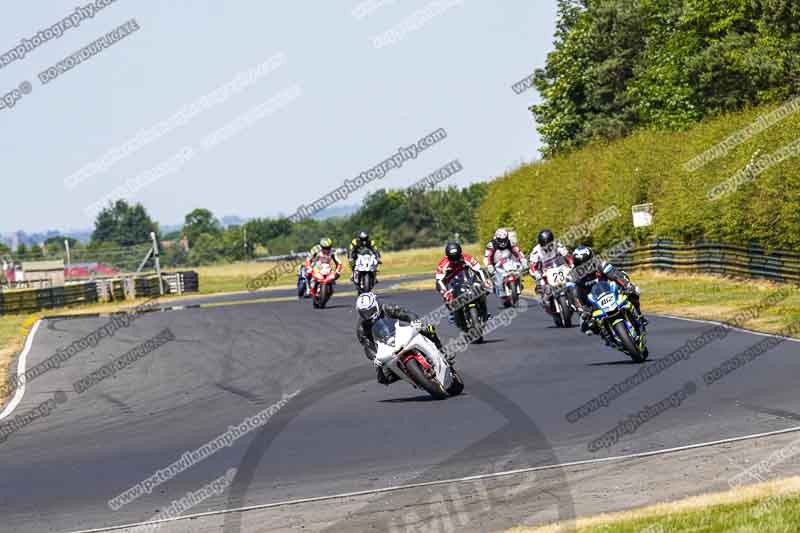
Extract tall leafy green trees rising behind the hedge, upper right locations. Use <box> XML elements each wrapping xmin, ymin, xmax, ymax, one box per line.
<box><xmin>531</xmin><ymin>0</ymin><xmax>800</xmax><ymax>158</ymax></box>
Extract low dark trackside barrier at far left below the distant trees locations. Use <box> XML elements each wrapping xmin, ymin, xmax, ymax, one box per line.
<box><xmin>0</xmin><ymin>271</ymin><xmax>200</xmax><ymax>315</ymax></box>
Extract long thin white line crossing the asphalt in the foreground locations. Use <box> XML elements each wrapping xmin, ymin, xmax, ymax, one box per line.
<box><xmin>64</xmin><ymin>426</ymin><xmax>800</xmax><ymax>533</ymax></box>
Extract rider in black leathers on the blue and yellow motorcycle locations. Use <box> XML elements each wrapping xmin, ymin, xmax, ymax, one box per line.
<box><xmin>567</xmin><ymin>246</ymin><xmax>648</xmax><ymax>338</ymax></box>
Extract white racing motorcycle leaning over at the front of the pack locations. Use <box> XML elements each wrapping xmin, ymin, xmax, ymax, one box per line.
<box><xmin>372</xmin><ymin>318</ymin><xmax>464</xmax><ymax>400</ymax></box>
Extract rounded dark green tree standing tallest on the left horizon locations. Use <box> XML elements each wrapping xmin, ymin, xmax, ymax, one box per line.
<box><xmin>92</xmin><ymin>200</ymin><xmax>159</xmax><ymax>246</ymax></box>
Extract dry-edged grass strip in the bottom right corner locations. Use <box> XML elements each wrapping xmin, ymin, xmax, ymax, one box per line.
<box><xmin>506</xmin><ymin>477</ymin><xmax>800</xmax><ymax>533</ymax></box>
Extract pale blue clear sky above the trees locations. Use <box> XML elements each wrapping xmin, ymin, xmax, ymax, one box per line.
<box><xmin>0</xmin><ymin>0</ymin><xmax>556</xmax><ymax>233</ymax></box>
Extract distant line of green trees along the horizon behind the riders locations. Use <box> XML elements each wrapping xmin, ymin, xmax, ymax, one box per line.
<box><xmin>37</xmin><ymin>183</ymin><xmax>488</xmax><ymax>271</ymax></box>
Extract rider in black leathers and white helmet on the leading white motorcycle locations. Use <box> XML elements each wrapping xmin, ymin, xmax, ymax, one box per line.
<box><xmin>356</xmin><ymin>292</ymin><xmax>455</xmax><ymax>385</ymax></box>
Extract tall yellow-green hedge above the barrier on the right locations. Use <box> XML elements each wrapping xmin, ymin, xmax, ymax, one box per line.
<box><xmin>478</xmin><ymin>105</ymin><xmax>800</xmax><ymax>252</ymax></box>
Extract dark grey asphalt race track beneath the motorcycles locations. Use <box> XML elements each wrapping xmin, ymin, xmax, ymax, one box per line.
<box><xmin>0</xmin><ymin>292</ymin><xmax>800</xmax><ymax>533</ymax></box>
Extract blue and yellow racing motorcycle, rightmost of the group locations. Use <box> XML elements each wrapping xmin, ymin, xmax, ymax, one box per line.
<box><xmin>589</xmin><ymin>279</ymin><xmax>650</xmax><ymax>363</ymax></box>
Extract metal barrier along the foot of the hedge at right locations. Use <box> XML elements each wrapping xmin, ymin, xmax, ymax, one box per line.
<box><xmin>612</xmin><ymin>239</ymin><xmax>800</xmax><ymax>284</ymax></box>
